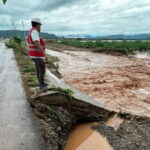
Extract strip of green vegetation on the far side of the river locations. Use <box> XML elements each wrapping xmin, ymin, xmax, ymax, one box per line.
<box><xmin>46</xmin><ymin>39</ymin><xmax>150</xmax><ymax>53</ymax></box>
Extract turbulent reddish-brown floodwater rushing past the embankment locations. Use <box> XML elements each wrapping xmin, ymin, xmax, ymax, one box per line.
<box><xmin>47</xmin><ymin>50</ymin><xmax>150</xmax><ymax>116</ymax></box>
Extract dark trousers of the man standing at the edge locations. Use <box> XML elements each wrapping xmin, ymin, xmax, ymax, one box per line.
<box><xmin>32</xmin><ymin>58</ymin><xmax>45</xmax><ymax>87</ymax></box>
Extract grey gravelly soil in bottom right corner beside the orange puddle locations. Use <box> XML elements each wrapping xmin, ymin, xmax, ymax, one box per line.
<box><xmin>92</xmin><ymin>115</ymin><xmax>150</xmax><ymax>150</ymax></box>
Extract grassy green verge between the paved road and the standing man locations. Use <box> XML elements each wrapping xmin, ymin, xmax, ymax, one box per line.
<box><xmin>6</xmin><ymin>36</ymin><xmax>38</xmax><ymax>87</ymax></box>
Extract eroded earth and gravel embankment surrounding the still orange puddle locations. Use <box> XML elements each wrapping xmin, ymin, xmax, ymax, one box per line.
<box><xmin>29</xmin><ymin>90</ymin><xmax>150</xmax><ymax>150</ymax></box>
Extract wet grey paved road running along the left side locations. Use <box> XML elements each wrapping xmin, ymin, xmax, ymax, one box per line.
<box><xmin>0</xmin><ymin>42</ymin><xmax>45</xmax><ymax>150</ymax></box>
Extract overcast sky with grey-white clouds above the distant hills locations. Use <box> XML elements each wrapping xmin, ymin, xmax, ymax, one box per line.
<box><xmin>0</xmin><ymin>0</ymin><xmax>150</xmax><ymax>35</ymax></box>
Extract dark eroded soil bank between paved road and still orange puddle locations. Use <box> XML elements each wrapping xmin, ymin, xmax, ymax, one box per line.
<box><xmin>32</xmin><ymin>99</ymin><xmax>114</xmax><ymax>150</ymax></box>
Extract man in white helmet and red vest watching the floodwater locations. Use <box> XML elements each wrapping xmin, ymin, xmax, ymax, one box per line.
<box><xmin>28</xmin><ymin>18</ymin><xmax>47</xmax><ymax>90</ymax></box>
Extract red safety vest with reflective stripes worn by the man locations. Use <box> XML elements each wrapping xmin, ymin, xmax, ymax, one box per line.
<box><xmin>28</xmin><ymin>28</ymin><xmax>45</xmax><ymax>58</ymax></box>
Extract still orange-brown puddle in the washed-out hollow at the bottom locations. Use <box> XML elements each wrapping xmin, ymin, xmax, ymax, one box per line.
<box><xmin>65</xmin><ymin>123</ymin><xmax>113</xmax><ymax>150</ymax></box>
